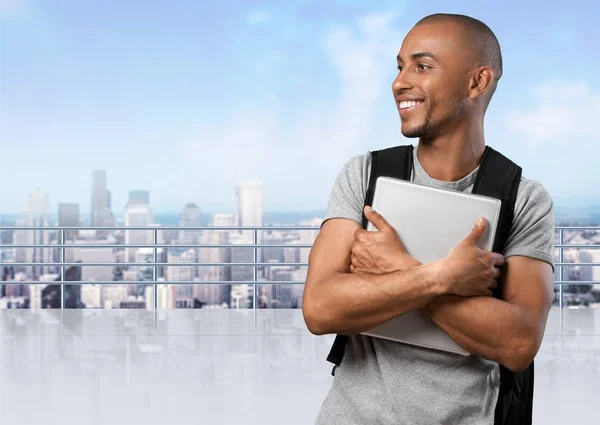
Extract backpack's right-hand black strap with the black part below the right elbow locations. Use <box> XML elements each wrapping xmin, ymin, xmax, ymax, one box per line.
<box><xmin>473</xmin><ymin>146</ymin><xmax>534</xmax><ymax>425</ymax></box>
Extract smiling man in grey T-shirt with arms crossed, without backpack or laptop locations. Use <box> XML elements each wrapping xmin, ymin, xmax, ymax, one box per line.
<box><xmin>303</xmin><ymin>14</ymin><xmax>554</xmax><ymax>425</ymax></box>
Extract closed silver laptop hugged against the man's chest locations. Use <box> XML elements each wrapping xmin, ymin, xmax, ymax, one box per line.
<box><xmin>363</xmin><ymin>177</ymin><xmax>501</xmax><ymax>356</ymax></box>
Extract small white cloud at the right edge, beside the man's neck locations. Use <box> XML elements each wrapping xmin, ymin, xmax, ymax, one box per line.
<box><xmin>506</xmin><ymin>82</ymin><xmax>600</xmax><ymax>144</ymax></box>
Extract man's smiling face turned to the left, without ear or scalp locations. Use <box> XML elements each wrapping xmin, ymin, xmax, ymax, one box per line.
<box><xmin>392</xmin><ymin>22</ymin><xmax>471</xmax><ymax>141</ymax></box>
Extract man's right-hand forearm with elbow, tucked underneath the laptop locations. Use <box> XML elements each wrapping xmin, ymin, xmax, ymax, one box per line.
<box><xmin>424</xmin><ymin>295</ymin><xmax>541</xmax><ymax>369</ymax></box>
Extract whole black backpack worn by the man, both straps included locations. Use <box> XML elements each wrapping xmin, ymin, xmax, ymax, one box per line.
<box><xmin>327</xmin><ymin>145</ymin><xmax>534</xmax><ymax>425</ymax></box>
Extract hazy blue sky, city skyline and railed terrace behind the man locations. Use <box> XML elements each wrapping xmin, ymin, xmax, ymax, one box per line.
<box><xmin>0</xmin><ymin>0</ymin><xmax>600</xmax><ymax>425</ymax></box>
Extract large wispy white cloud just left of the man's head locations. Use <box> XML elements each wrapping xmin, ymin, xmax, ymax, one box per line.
<box><xmin>173</xmin><ymin>13</ymin><xmax>403</xmax><ymax>210</ymax></box>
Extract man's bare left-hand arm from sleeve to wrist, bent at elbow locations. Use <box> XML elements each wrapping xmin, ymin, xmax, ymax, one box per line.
<box><xmin>302</xmin><ymin>219</ymin><xmax>447</xmax><ymax>335</ymax></box>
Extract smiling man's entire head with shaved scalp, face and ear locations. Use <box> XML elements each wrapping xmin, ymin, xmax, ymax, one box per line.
<box><xmin>392</xmin><ymin>13</ymin><xmax>502</xmax><ymax>139</ymax></box>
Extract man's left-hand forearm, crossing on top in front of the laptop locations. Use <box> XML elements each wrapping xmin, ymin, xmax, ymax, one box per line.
<box><xmin>303</xmin><ymin>263</ymin><xmax>445</xmax><ymax>335</ymax></box>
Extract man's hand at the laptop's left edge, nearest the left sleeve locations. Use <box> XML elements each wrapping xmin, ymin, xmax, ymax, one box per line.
<box><xmin>350</xmin><ymin>206</ymin><xmax>421</xmax><ymax>274</ymax></box>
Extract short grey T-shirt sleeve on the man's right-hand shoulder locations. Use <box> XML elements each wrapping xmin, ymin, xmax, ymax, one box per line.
<box><xmin>503</xmin><ymin>178</ymin><xmax>555</xmax><ymax>269</ymax></box>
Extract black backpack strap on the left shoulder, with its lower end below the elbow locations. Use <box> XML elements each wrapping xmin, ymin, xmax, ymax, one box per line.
<box><xmin>327</xmin><ymin>145</ymin><xmax>414</xmax><ymax>375</ymax></box>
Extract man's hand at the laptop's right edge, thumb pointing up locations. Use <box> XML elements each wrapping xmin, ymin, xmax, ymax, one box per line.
<box><xmin>442</xmin><ymin>218</ymin><xmax>504</xmax><ymax>296</ymax></box>
